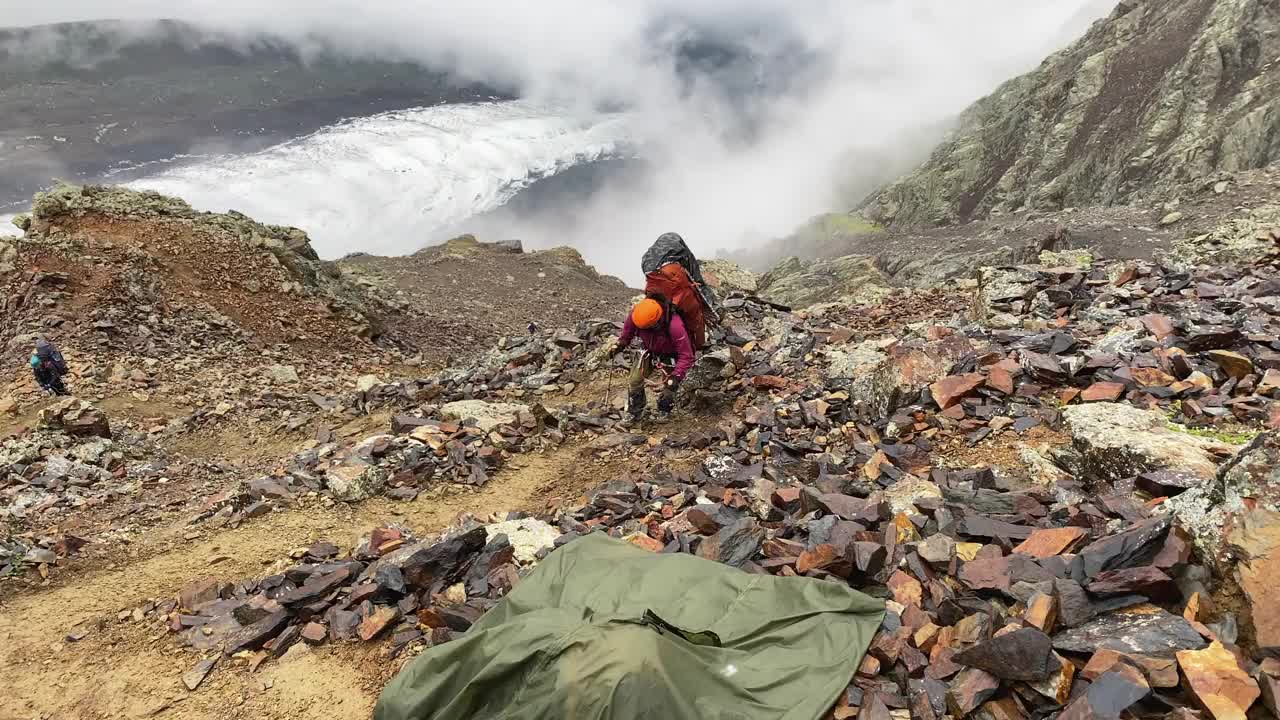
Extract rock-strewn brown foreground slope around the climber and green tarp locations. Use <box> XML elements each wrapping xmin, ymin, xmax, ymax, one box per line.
<box><xmin>0</xmin><ymin>172</ymin><xmax>1280</xmax><ymax>720</ymax></box>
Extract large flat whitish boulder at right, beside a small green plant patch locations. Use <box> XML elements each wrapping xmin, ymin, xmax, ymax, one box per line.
<box><xmin>1062</xmin><ymin>402</ymin><xmax>1235</xmax><ymax>482</ymax></box>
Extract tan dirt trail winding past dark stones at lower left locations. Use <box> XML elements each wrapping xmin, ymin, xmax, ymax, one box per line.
<box><xmin>0</xmin><ymin>445</ymin><xmax>602</xmax><ymax>720</ymax></box>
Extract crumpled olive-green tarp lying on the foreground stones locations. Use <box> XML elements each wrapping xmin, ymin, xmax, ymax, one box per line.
<box><xmin>374</xmin><ymin>533</ymin><xmax>884</xmax><ymax>720</ymax></box>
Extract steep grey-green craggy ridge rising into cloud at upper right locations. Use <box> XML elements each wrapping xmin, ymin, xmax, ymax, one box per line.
<box><xmin>867</xmin><ymin>0</ymin><xmax>1280</xmax><ymax>224</ymax></box>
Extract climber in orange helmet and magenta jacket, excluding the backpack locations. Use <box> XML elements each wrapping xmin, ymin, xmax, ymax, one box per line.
<box><xmin>611</xmin><ymin>295</ymin><xmax>694</xmax><ymax>421</ymax></box>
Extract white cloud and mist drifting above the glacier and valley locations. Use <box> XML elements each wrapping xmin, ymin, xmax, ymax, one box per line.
<box><xmin>0</xmin><ymin>0</ymin><xmax>1114</xmax><ymax>278</ymax></box>
